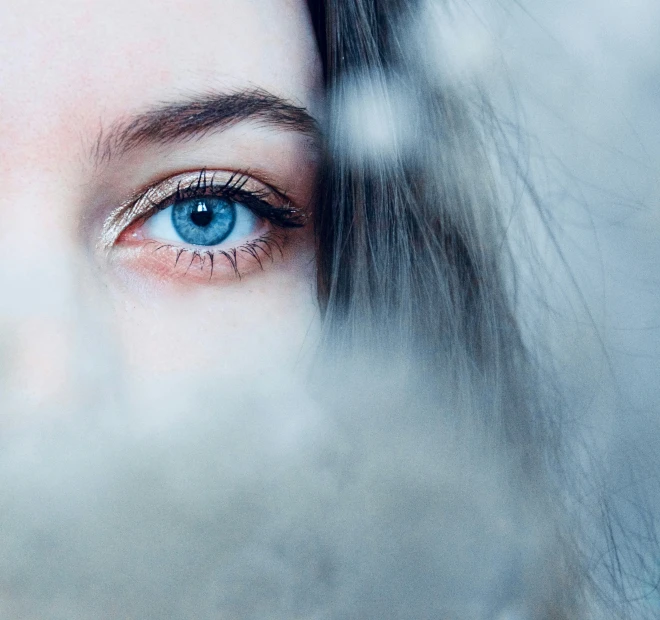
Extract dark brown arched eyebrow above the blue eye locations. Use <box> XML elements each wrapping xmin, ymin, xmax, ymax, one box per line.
<box><xmin>93</xmin><ymin>89</ymin><xmax>320</xmax><ymax>163</ymax></box>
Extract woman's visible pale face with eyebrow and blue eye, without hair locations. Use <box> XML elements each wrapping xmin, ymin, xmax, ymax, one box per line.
<box><xmin>0</xmin><ymin>0</ymin><xmax>321</xmax><ymax>422</ymax></box>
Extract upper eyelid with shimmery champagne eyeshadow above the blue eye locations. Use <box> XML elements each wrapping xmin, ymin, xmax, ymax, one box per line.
<box><xmin>99</xmin><ymin>169</ymin><xmax>289</xmax><ymax>250</ymax></box>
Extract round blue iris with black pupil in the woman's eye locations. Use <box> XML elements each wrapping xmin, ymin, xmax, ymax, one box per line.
<box><xmin>172</xmin><ymin>197</ymin><xmax>236</xmax><ymax>245</ymax></box>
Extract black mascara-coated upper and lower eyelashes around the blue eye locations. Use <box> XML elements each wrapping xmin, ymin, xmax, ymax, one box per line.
<box><xmin>117</xmin><ymin>169</ymin><xmax>307</xmax><ymax>279</ymax></box>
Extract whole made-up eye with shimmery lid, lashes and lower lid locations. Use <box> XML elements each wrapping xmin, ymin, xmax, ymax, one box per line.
<box><xmin>100</xmin><ymin>169</ymin><xmax>308</xmax><ymax>281</ymax></box>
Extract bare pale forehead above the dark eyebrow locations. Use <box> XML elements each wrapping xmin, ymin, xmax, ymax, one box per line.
<box><xmin>0</xmin><ymin>0</ymin><xmax>320</xmax><ymax>146</ymax></box>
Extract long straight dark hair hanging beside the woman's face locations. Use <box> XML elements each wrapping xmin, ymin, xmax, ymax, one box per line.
<box><xmin>308</xmin><ymin>0</ymin><xmax>660</xmax><ymax>619</ymax></box>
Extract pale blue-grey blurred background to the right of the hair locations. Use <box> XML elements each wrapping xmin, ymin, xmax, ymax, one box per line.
<box><xmin>470</xmin><ymin>0</ymin><xmax>660</xmax><ymax>458</ymax></box>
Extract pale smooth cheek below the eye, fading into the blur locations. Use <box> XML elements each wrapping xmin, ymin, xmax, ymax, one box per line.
<box><xmin>104</xmin><ymin>235</ymin><xmax>320</xmax><ymax>387</ymax></box>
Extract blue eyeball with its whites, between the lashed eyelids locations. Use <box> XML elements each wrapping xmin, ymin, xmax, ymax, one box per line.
<box><xmin>144</xmin><ymin>196</ymin><xmax>258</xmax><ymax>247</ymax></box>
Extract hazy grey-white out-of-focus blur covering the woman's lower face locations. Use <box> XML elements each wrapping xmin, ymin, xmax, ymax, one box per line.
<box><xmin>0</xmin><ymin>366</ymin><xmax>554</xmax><ymax>620</ymax></box>
